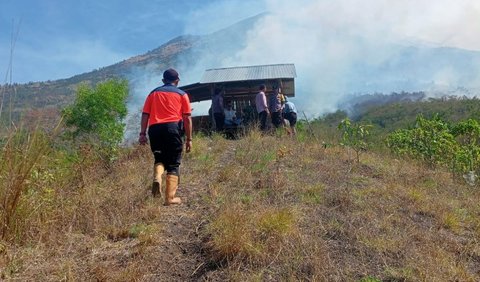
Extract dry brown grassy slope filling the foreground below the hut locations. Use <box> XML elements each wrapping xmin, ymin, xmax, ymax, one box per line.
<box><xmin>0</xmin><ymin>129</ymin><xmax>480</xmax><ymax>281</ymax></box>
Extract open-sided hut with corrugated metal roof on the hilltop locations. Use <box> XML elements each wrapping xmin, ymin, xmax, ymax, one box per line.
<box><xmin>180</xmin><ymin>64</ymin><xmax>296</xmax><ymax>131</ymax></box>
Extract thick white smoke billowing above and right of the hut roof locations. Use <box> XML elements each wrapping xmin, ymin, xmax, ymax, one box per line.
<box><xmin>183</xmin><ymin>0</ymin><xmax>480</xmax><ymax>115</ymax></box>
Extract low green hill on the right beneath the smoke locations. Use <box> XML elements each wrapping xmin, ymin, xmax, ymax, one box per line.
<box><xmin>315</xmin><ymin>92</ymin><xmax>480</xmax><ymax>141</ymax></box>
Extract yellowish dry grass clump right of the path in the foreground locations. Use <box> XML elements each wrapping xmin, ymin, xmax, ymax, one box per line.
<box><xmin>208</xmin><ymin>205</ymin><xmax>296</xmax><ymax>264</ymax></box>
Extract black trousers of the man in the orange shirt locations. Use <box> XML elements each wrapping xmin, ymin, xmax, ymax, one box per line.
<box><xmin>148</xmin><ymin>122</ymin><xmax>183</xmax><ymax>175</ymax></box>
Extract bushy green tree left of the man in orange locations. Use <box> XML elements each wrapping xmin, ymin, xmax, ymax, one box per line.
<box><xmin>63</xmin><ymin>79</ymin><xmax>128</xmax><ymax>158</ymax></box>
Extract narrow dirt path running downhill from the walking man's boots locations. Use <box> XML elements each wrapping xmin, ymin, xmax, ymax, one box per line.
<box><xmin>142</xmin><ymin>177</ymin><xmax>216</xmax><ymax>281</ymax></box>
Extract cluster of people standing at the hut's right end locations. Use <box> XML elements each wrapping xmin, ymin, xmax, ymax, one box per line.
<box><xmin>255</xmin><ymin>84</ymin><xmax>297</xmax><ymax>135</ymax></box>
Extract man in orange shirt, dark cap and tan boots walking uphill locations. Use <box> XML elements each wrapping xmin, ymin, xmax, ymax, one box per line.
<box><xmin>138</xmin><ymin>69</ymin><xmax>192</xmax><ymax>206</ymax></box>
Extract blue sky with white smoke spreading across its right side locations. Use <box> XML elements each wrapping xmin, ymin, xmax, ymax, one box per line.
<box><xmin>0</xmin><ymin>0</ymin><xmax>480</xmax><ymax>118</ymax></box>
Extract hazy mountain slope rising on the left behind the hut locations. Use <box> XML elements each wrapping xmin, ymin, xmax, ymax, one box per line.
<box><xmin>0</xmin><ymin>12</ymin><xmax>262</xmax><ymax>118</ymax></box>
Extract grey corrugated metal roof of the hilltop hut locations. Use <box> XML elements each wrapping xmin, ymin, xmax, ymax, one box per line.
<box><xmin>200</xmin><ymin>64</ymin><xmax>297</xmax><ymax>83</ymax></box>
